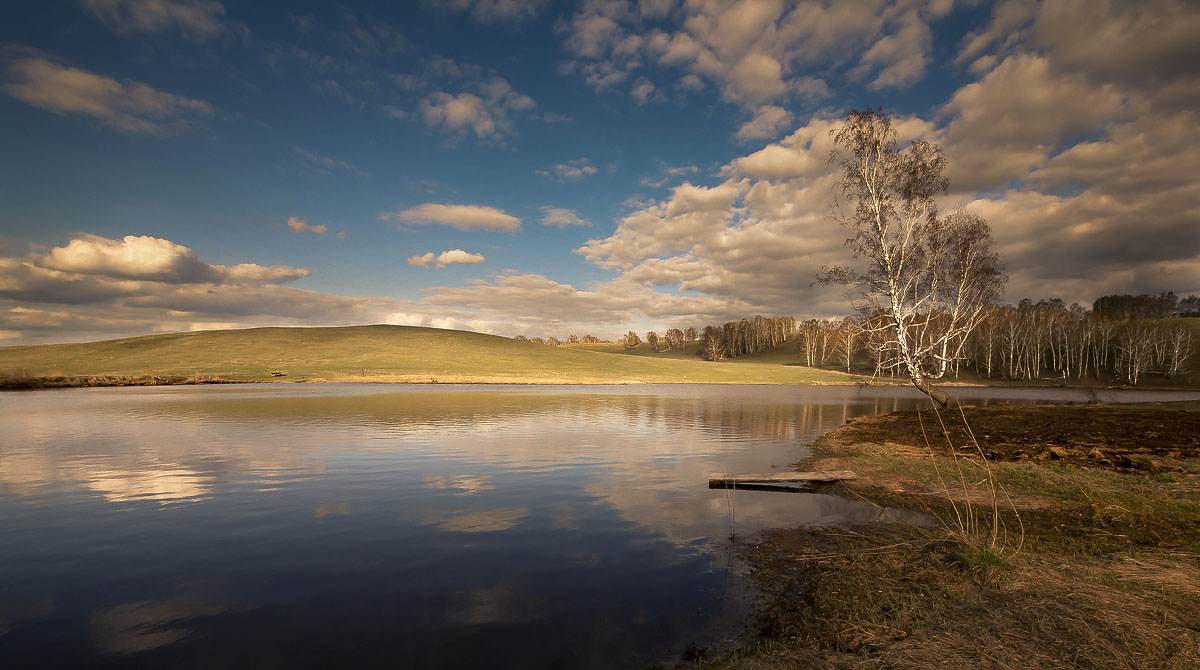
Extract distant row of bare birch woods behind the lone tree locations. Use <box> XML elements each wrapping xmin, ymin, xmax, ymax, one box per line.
<box><xmin>516</xmin><ymin>293</ymin><xmax>1200</xmax><ymax>384</ymax></box>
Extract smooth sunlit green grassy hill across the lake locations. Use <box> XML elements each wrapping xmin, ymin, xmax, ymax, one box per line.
<box><xmin>0</xmin><ymin>325</ymin><xmax>857</xmax><ymax>384</ymax></box>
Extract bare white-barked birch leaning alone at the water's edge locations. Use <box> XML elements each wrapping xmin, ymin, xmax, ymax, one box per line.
<box><xmin>820</xmin><ymin>109</ymin><xmax>1006</xmax><ymax>406</ymax></box>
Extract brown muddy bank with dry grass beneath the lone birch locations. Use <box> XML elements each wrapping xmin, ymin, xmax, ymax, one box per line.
<box><xmin>700</xmin><ymin>402</ymin><xmax>1200</xmax><ymax>668</ymax></box>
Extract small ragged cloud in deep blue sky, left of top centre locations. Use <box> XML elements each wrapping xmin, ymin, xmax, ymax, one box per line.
<box><xmin>419</xmin><ymin>77</ymin><xmax>536</xmax><ymax>142</ymax></box>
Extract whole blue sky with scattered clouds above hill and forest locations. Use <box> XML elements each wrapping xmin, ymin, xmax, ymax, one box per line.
<box><xmin>0</xmin><ymin>0</ymin><xmax>1200</xmax><ymax>345</ymax></box>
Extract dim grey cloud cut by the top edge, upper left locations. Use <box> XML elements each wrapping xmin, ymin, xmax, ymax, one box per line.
<box><xmin>79</xmin><ymin>0</ymin><xmax>234</xmax><ymax>40</ymax></box>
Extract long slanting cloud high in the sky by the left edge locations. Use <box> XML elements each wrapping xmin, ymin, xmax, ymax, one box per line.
<box><xmin>4</xmin><ymin>56</ymin><xmax>214</xmax><ymax>136</ymax></box>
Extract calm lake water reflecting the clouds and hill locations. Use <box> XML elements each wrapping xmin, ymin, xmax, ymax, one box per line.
<box><xmin>0</xmin><ymin>384</ymin><xmax>1195</xmax><ymax>668</ymax></box>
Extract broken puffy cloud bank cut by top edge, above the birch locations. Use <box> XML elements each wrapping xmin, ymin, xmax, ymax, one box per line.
<box><xmin>563</xmin><ymin>0</ymin><xmax>952</xmax><ymax>108</ymax></box>
